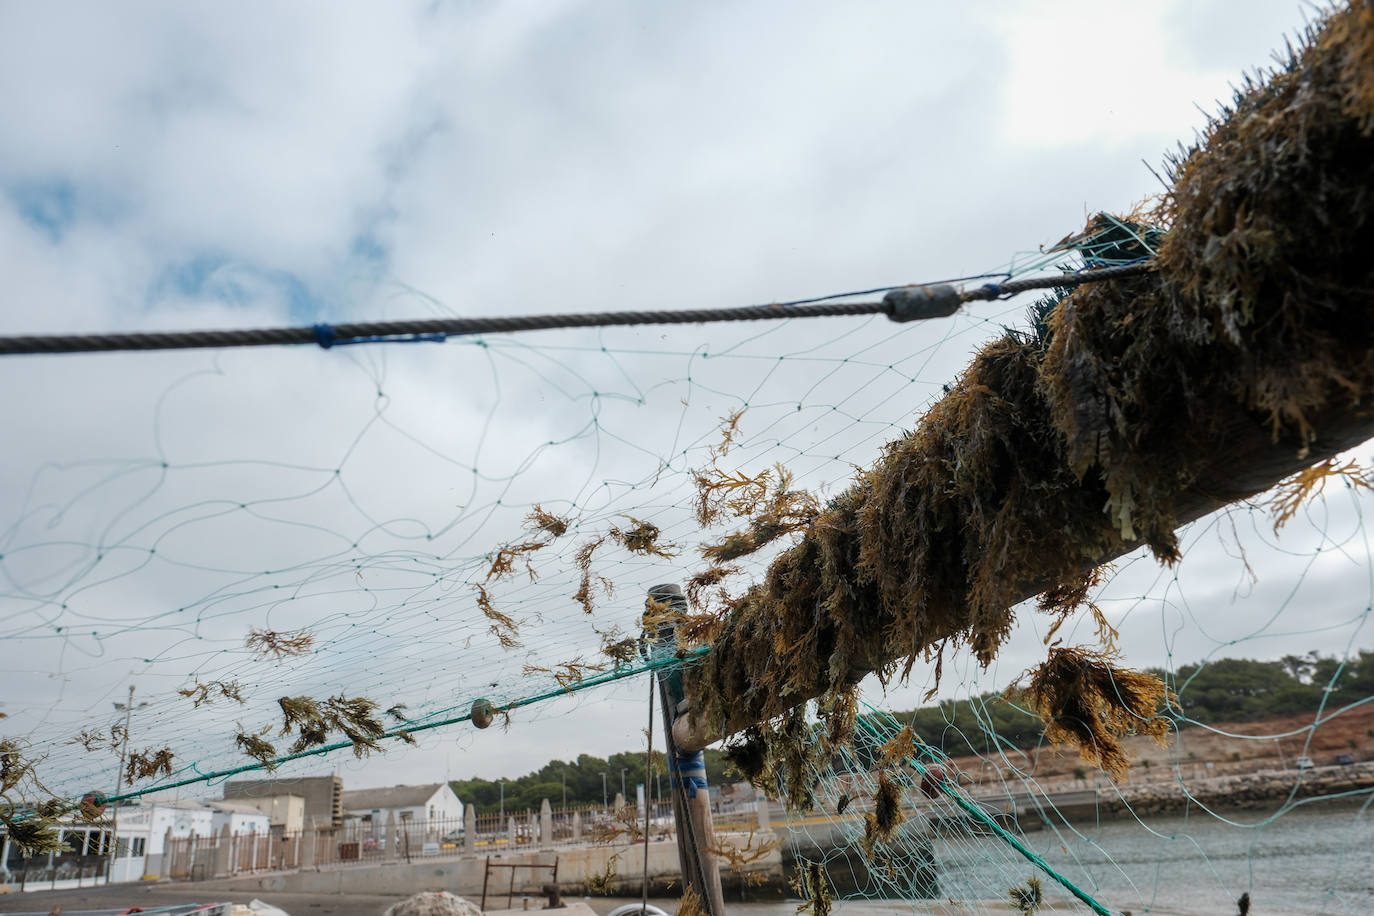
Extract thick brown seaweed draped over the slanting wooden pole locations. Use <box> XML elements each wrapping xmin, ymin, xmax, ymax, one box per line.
<box><xmin>687</xmin><ymin>4</ymin><xmax>1374</xmax><ymax>791</ymax></box>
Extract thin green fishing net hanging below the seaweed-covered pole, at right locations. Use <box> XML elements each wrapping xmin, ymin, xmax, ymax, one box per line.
<box><xmin>778</xmin><ymin>483</ymin><xmax>1374</xmax><ymax>913</ymax></box>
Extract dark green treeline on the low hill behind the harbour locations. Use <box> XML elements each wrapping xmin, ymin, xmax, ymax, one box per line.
<box><xmin>452</xmin><ymin>650</ymin><xmax>1374</xmax><ymax>813</ymax></box>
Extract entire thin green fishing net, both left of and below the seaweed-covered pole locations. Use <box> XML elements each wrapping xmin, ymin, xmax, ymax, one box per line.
<box><xmin>0</xmin><ymin>10</ymin><xmax>1374</xmax><ymax>913</ymax></box>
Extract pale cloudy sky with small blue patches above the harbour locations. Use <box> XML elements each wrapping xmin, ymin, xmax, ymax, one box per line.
<box><xmin>0</xmin><ymin>0</ymin><xmax>1374</xmax><ymax>791</ymax></box>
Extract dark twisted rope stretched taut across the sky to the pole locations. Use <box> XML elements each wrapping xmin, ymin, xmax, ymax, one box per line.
<box><xmin>0</xmin><ymin>261</ymin><xmax>1150</xmax><ymax>356</ymax></box>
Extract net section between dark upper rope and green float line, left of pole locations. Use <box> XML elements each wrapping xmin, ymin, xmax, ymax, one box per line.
<box><xmin>0</xmin><ymin>255</ymin><xmax>1062</xmax><ymax>797</ymax></box>
